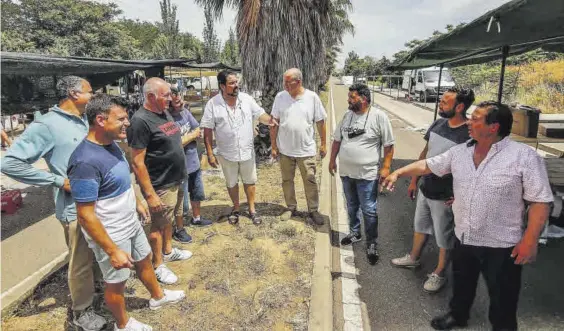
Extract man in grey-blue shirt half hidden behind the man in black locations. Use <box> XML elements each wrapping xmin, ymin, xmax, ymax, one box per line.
<box><xmin>170</xmin><ymin>88</ymin><xmax>212</xmax><ymax>243</ymax></box>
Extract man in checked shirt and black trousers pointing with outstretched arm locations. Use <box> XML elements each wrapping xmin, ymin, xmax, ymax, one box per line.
<box><xmin>382</xmin><ymin>101</ymin><xmax>554</xmax><ymax>331</ymax></box>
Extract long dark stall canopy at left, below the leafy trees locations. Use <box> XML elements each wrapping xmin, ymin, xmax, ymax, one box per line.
<box><xmin>0</xmin><ymin>52</ymin><xmax>198</xmax><ymax>76</ymax></box>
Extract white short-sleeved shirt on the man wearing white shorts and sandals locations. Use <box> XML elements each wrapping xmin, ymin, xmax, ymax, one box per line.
<box><xmin>200</xmin><ymin>92</ymin><xmax>264</xmax><ymax>162</ymax></box>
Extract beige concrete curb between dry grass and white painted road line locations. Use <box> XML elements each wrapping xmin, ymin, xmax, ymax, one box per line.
<box><xmin>308</xmin><ymin>87</ymin><xmax>333</xmax><ymax>331</ymax></box>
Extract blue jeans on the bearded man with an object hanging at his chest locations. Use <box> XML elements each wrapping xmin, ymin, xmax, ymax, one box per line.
<box><xmin>341</xmin><ymin>177</ymin><xmax>378</xmax><ymax>246</ymax></box>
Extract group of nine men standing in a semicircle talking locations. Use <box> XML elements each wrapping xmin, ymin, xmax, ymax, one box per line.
<box><xmin>2</xmin><ymin>68</ymin><xmax>552</xmax><ymax>330</ymax></box>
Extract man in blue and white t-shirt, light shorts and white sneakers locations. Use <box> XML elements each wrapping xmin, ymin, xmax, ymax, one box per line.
<box><xmin>68</xmin><ymin>94</ymin><xmax>186</xmax><ymax>331</ymax></box>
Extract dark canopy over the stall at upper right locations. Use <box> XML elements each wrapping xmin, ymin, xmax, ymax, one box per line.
<box><xmin>392</xmin><ymin>0</ymin><xmax>564</xmax><ymax>69</ymax></box>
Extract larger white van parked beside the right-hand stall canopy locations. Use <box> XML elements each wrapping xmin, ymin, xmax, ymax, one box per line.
<box><xmin>401</xmin><ymin>67</ymin><xmax>455</xmax><ymax>102</ymax></box>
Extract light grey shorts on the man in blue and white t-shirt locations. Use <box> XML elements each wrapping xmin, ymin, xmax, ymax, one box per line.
<box><xmin>88</xmin><ymin>223</ymin><xmax>151</xmax><ymax>284</ymax></box>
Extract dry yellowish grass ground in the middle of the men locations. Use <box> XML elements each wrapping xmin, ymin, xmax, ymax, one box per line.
<box><xmin>2</xmin><ymin>163</ymin><xmax>322</xmax><ymax>331</ymax></box>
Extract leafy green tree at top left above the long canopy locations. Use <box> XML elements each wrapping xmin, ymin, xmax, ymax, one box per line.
<box><xmin>2</xmin><ymin>0</ymin><xmax>141</xmax><ymax>59</ymax></box>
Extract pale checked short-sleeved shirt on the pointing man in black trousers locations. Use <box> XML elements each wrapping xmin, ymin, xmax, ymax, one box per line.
<box><xmin>427</xmin><ymin>137</ymin><xmax>554</xmax><ymax>248</ymax></box>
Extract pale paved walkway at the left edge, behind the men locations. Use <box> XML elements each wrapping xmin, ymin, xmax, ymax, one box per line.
<box><xmin>0</xmin><ymin>154</ymin><xmax>67</xmax><ymax>310</ymax></box>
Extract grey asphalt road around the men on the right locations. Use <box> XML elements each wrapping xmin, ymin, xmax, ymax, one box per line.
<box><xmin>333</xmin><ymin>81</ymin><xmax>564</xmax><ymax>330</ymax></box>
